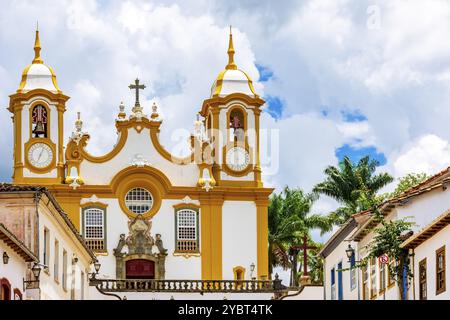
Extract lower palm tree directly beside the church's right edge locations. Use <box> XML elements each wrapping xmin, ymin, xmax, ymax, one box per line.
<box><xmin>269</xmin><ymin>187</ymin><xmax>332</xmax><ymax>277</ymax></box>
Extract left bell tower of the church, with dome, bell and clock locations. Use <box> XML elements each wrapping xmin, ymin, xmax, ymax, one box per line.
<box><xmin>8</xmin><ymin>30</ymin><xmax>69</xmax><ymax>185</ymax></box>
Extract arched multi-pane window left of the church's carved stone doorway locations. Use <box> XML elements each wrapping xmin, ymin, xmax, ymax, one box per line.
<box><xmin>83</xmin><ymin>207</ymin><xmax>106</xmax><ymax>251</ymax></box>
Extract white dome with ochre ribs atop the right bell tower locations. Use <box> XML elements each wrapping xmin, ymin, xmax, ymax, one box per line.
<box><xmin>211</xmin><ymin>69</ymin><xmax>258</xmax><ymax>97</ymax></box>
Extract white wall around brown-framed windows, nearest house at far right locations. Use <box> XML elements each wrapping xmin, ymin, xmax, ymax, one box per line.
<box><xmin>414</xmin><ymin>225</ymin><xmax>450</xmax><ymax>300</ymax></box>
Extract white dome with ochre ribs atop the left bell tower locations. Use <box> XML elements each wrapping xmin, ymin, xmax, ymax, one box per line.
<box><xmin>19</xmin><ymin>63</ymin><xmax>61</xmax><ymax>93</ymax></box>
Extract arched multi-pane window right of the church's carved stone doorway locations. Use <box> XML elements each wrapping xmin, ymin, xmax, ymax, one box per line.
<box><xmin>175</xmin><ymin>208</ymin><xmax>199</xmax><ymax>252</ymax></box>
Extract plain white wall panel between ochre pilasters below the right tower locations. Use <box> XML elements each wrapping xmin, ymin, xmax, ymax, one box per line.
<box><xmin>222</xmin><ymin>201</ymin><xmax>257</xmax><ymax>280</ymax></box>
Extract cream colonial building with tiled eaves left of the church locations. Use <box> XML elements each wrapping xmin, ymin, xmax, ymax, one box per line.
<box><xmin>0</xmin><ymin>184</ymin><xmax>96</xmax><ymax>300</ymax></box>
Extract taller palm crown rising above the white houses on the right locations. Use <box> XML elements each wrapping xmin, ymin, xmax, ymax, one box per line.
<box><xmin>313</xmin><ymin>156</ymin><xmax>394</xmax><ymax>224</ymax></box>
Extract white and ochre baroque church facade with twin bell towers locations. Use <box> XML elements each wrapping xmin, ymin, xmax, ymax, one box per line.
<box><xmin>8</xmin><ymin>26</ymin><xmax>273</xmax><ymax>280</ymax></box>
